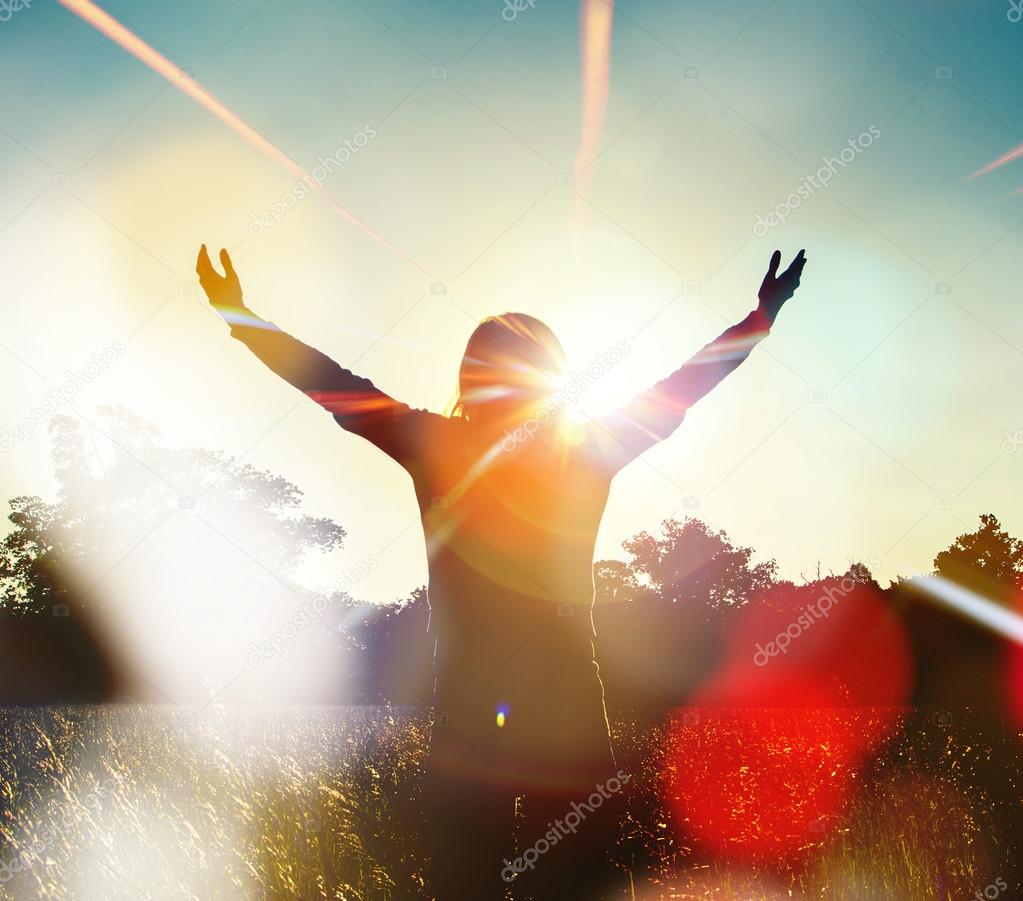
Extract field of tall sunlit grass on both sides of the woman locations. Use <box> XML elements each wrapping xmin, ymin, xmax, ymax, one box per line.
<box><xmin>0</xmin><ymin>706</ymin><xmax>1020</xmax><ymax>901</ymax></box>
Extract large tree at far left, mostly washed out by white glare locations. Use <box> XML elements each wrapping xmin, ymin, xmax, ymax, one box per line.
<box><xmin>0</xmin><ymin>408</ymin><xmax>360</xmax><ymax>703</ymax></box>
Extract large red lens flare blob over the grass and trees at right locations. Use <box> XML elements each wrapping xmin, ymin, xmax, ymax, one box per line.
<box><xmin>661</xmin><ymin>577</ymin><xmax>911</xmax><ymax>863</ymax></box>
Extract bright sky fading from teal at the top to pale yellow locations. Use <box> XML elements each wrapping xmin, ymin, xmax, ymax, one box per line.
<box><xmin>0</xmin><ymin>0</ymin><xmax>1023</xmax><ymax>601</ymax></box>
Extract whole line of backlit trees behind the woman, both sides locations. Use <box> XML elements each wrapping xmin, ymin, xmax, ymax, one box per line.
<box><xmin>0</xmin><ymin>408</ymin><xmax>1023</xmax><ymax>717</ymax></box>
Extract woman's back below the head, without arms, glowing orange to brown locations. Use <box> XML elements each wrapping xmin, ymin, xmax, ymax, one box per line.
<box><xmin>407</xmin><ymin>417</ymin><xmax>611</xmax><ymax>782</ymax></box>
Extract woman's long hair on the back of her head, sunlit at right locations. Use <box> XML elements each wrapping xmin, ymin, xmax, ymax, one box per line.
<box><xmin>451</xmin><ymin>313</ymin><xmax>565</xmax><ymax>419</ymax></box>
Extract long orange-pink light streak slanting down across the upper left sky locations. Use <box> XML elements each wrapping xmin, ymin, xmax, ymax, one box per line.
<box><xmin>57</xmin><ymin>0</ymin><xmax>430</xmax><ymax>275</ymax></box>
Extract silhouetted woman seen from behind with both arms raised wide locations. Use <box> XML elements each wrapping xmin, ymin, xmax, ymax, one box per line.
<box><xmin>196</xmin><ymin>245</ymin><xmax>806</xmax><ymax>901</ymax></box>
